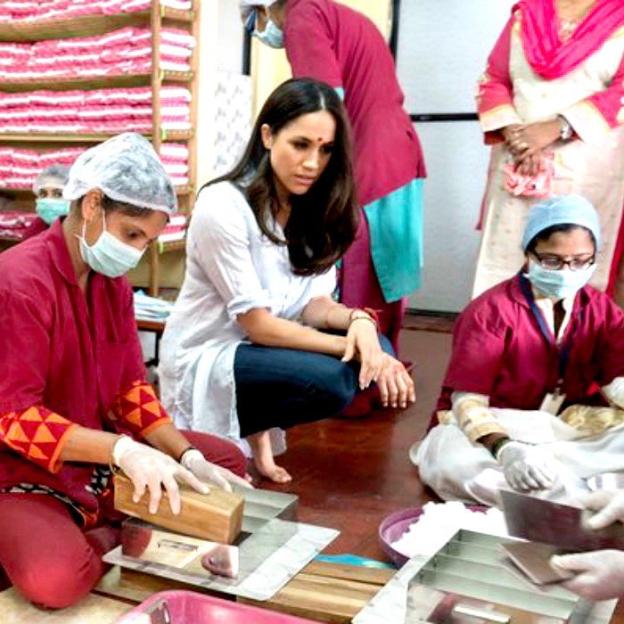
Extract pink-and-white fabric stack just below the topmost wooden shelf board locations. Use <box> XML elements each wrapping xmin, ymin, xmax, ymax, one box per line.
<box><xmin>0</xmin><ymin>27</ymin><xmax>195</xmax><ymax>82</ymax></box>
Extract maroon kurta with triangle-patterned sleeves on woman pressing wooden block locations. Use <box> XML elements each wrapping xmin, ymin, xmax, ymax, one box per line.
<box><xmin>0</xmin><ymin>220</ymin><xmax>163</xmax><ymax>511</ymax></box>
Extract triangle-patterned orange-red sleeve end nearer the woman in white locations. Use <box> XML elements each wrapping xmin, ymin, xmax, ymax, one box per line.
<box><xmin>111</xmin><ymin>380</ymin><xmax>172</xmax><ymax>437</ymax></box>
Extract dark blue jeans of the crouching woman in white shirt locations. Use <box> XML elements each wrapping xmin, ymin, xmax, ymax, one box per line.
<box><xmin>234</xmin><ymin>336</ymin><xmax>393</xmax><ymax>438</ymax></box>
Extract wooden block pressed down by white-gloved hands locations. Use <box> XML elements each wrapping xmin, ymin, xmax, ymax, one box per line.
<box><xmin>114</xmin><ymin>473</ymin><xmax>245</xmax><ymax>544</ymax></box>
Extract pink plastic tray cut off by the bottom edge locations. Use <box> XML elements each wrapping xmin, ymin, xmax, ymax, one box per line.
<box><xmin>115</xmin><ymin>590</ymin><xmax>314</xmax><ymax>624</ymax></box>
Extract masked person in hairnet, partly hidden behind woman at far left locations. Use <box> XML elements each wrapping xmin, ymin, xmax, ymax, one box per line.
<box><xmin>23</xmin><ymin>165</ymin><xmax>70</xmax><ymax>240</ymax></box>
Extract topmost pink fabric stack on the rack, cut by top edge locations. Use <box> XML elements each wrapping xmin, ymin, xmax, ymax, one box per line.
<box><xmin>0</xmin><ymin>0</ymin><xmax>193</xmax><ymax>22</ymax></box>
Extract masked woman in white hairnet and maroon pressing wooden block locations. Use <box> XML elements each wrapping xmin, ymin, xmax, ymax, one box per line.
<box><xmin>0</xmin><ymin>133</ymin><xmax>250</xmax><ymax>608</ymax></box>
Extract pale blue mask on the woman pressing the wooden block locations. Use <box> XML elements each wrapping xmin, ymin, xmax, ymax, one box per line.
<box><xmin>78</xmin><ymin>217</ymin><xmax>145</xmax><ymax>277</ymax></box>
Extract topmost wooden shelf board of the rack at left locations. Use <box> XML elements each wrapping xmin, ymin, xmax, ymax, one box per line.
<box><xmin>0</xmin><ymin>7</ymin><xmax>195</xmax><ymax>43</ymax></box>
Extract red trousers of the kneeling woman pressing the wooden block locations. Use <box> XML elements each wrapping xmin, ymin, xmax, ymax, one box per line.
<box><xmin>0</xmin><ymin>431</ymin><xmax>245</xmax><ymax>609</ymax></box>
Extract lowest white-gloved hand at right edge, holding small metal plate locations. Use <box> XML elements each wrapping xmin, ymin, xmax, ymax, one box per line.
<box><xmin>550</xmin><ymin>550</ymin><xmax>624</xmax><ymax>600</ymax></box>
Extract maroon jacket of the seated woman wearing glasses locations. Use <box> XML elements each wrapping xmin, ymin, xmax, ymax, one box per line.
<box><xmin>437</xmin><ymin>276</ymin><xmax>624</xmax><ymax>424</ymax></box>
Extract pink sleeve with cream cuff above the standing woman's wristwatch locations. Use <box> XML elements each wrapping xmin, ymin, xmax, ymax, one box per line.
<box><xmin>561</xmin><ymin>51</ymin><xmax>624</xmax><ymax>141</ymax></box>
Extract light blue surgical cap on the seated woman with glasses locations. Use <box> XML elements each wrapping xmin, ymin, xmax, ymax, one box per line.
<box><xmin>522</xmin><ymin>195</ymin><xmax>600</xmax><ymax>251</ymax></box>
